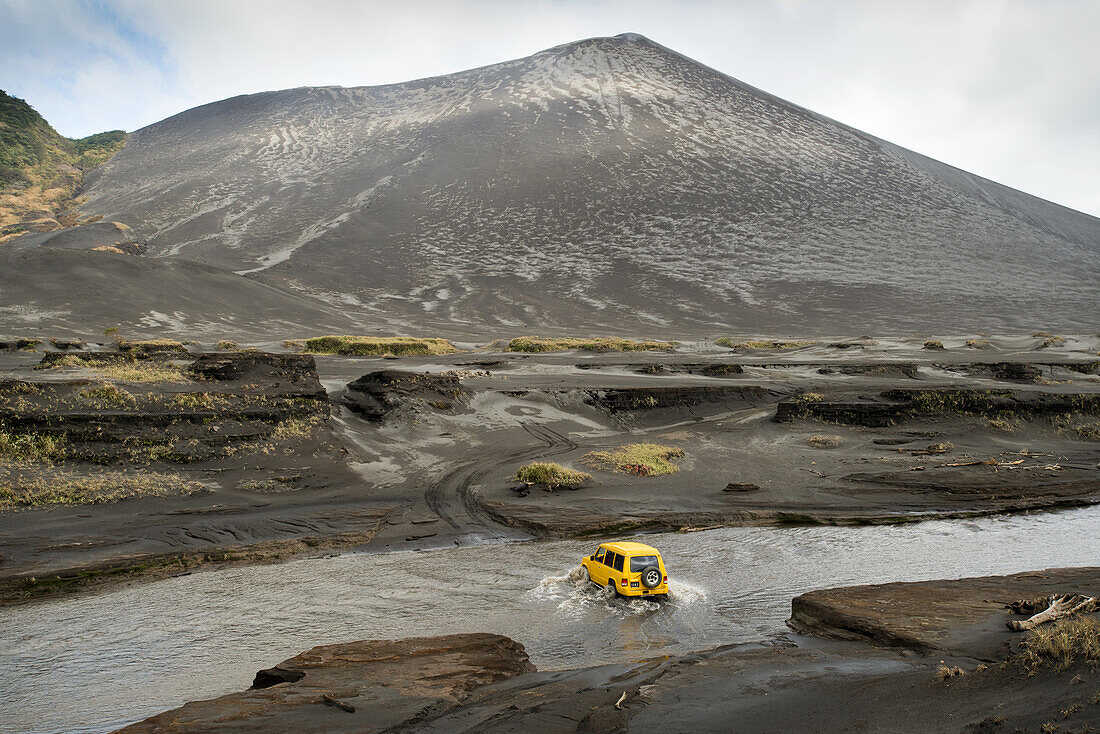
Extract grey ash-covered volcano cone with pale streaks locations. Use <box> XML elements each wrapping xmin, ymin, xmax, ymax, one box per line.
<box><xmin>70</xmin><ymin>35</ymin><xmax>1100</xmax><ymax>333</ymax></box>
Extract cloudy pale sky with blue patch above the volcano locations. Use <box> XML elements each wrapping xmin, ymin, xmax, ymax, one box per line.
<box><xmin>0</xmin><ymin>0</ymin><xmax>1100</xmax><ymax>216</ymax></box>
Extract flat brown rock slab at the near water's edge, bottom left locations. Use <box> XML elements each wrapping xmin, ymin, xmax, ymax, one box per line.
<box><xmin>121</xmin><ymin>634</ymin><xmax>535</xmax><ymax>734</ymax></box>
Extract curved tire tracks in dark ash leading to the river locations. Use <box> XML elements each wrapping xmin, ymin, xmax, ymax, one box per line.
<box><xmin>424</xmin><ymin>423</ymin><xmax>576</xmax><ymax>530</ymax></box>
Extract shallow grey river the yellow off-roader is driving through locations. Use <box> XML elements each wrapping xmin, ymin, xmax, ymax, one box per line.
<box><xmin>0</xmin><ymin>507</ymin><xmax>1100</xmax><ymax>732</ymax></box>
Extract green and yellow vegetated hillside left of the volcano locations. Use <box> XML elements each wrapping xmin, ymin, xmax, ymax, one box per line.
<box><xmin>0</xmin><ymin>90</ymin><xmax>127</xmax><ymax>242</ymax></box>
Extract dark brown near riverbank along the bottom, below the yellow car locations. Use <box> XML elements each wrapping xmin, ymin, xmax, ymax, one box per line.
<box><xmin>122</xmin><ymin>567</ymin><xmax>1100</xmax><ymax>734</ymax></box>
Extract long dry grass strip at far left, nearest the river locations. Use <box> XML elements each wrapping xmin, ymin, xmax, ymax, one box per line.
<box><xmin>0</xmin><ymin>472</ymin><xmax>206</xmax><ymax>510</ymax></box>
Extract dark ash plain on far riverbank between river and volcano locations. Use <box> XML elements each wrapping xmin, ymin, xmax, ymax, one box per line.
<box><xmin>0</xmin><ymin>339</ymin><xmax>1100</xmax><ymax>603</ymax></box>
